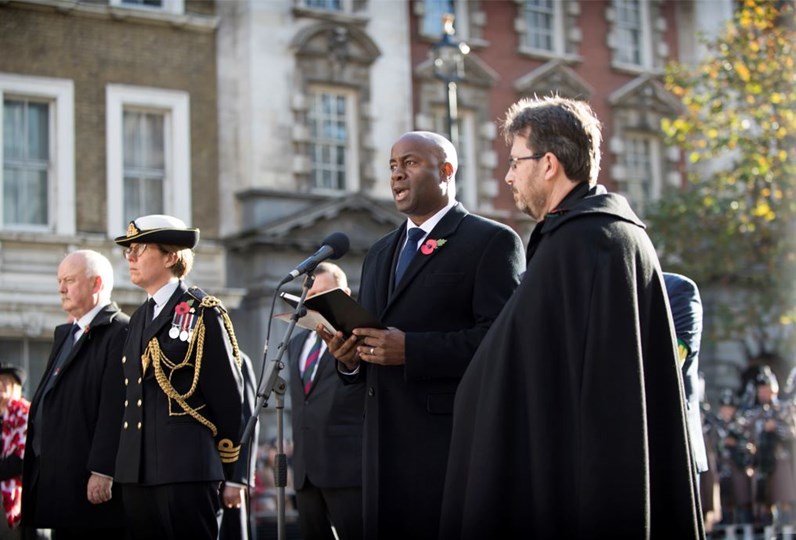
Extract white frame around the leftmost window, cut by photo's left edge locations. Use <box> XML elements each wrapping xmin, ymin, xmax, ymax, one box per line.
<box><xmin>0</xmin><ymin>73</ymin><xmax>76</xmax><ymax>235</ymax></box>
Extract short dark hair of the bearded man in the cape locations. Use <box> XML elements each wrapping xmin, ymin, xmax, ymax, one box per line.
<box><xmin>502</xmin><ymin>96</ymin><xmax>602</xmax><ymax>185</ymax></box>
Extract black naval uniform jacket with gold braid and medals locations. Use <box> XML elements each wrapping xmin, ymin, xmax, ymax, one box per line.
<box><xmin>116</xmin><ymin>282</ymin><xmax>242</xmax><ymax>485</ymax></box>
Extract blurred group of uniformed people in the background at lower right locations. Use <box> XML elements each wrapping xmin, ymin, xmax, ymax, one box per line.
<box><xmin>700</xmin><ymin>366</ymin><xmax>796</xmax><ymax>534</ymax></box>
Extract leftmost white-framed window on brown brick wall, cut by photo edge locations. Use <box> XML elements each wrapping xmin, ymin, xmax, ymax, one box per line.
<box><xmin>0</xmin><ymin>73</ymin><xmax>75</xmax><ymax>235</ymax></box>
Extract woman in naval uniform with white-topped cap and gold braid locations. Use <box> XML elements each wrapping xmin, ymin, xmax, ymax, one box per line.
<box><xmin>115</xmin><ymin>215</ymin><xmax>246</xmax><ymax>540</ymax></box>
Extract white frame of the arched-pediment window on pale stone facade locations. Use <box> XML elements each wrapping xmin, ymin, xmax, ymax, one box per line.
<box><xmin>307</xmin><ymin>84</ymin><xmax>361</xmax><ymax>193</ymax></box>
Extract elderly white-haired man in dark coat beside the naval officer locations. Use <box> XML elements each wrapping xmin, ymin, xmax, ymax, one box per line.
<box><xmin>22</xmin><ymin>250</ymin><xmax>129</xmax><ymax>539</ymax></box>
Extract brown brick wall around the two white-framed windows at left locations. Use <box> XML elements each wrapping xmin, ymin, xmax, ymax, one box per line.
<box><xmin>0</xmin><ymin>2</ymin><xmax>219</xmax><ymax>238</ymax></box>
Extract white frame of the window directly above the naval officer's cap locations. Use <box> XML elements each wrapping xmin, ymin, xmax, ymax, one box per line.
<box><xmin>105</xmin><ymin>84</ymin><xmax>191</xmax><ymax>238</ymax></box>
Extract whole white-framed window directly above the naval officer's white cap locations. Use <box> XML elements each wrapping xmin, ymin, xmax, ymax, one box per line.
<box><xmin>106</xmin><ymin>85</ymin><xmax>191</xmax><ymax>236</ymax></box>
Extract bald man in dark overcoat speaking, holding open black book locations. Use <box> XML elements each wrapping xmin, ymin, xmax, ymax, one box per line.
<box><xmin>319</xmin><ymin>131</ymin><xmax>525</xmax><ymax>540</ymax></box>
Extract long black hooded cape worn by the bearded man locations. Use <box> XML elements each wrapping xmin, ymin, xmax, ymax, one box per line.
<box><xmin>440</xmin><ymin>185</ymin><xmax>704</xmax><ymax>540</ymax></box>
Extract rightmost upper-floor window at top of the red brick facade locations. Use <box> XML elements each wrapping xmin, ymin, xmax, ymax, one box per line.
<box><xmin>614</xmin><ymin>0</ymin><xmax>650</xmax><ymax>67</ymax></box>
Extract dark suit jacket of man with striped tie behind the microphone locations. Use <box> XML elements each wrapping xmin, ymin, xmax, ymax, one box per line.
<box><xmin>286</xmin><ymin>331</ymin><xmax>365</xmax><ymax>489</ymax></box>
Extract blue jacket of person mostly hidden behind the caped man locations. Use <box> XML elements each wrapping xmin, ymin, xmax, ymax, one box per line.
<box><xmin>663</xmin><ymin>272</ymin><xmax>708</xmax><ymax>472</ymax></box>
